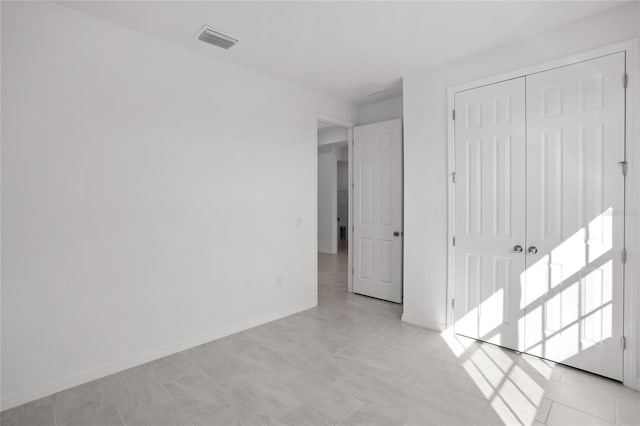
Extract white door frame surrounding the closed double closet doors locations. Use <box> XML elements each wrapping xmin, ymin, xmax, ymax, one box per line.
<box><xmin>445</xmin><ymin>38</ymin><xmax>640</xmax><ymax>390</ymax></box>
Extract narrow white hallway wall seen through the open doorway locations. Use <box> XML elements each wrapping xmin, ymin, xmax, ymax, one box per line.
<box><xmin>318</xmin><ymin>145</ymin><xmax>338</xmax><ymax>253</ymax></box>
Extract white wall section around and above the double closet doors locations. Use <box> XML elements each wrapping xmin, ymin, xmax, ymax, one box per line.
<box><xmin>403</xmin><ymin>3</ymin><xmax>638</xmax><ymax>329</ymax></box>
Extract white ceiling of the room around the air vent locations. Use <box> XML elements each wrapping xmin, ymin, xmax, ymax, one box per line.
<box><xmin>62</xmin><ymin>1</ymin><xmax>620</xmax><ymax>105</ymax></box>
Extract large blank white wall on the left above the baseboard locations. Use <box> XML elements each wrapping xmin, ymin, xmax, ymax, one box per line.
<box><xmin>2</xmin><ymin>2</ymin><xmax>356</xmax><ymax>409</ymax></box>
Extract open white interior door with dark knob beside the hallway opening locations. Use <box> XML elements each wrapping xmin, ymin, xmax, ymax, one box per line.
<box><xmin>353</xmin><ymin>120</ymin><xmax>402</xmax><ymax>303</ymax></box>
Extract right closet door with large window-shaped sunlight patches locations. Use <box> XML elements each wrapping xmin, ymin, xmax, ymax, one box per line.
<box><xmin>520</xmin><ymin>53</ymin><xmax>625</xmax><ymax>380</ymax></box>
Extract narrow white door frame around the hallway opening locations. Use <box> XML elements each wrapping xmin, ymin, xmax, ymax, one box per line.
<box><xmin>313</xmin><ymin>113</ymin><xmax>355</xmax><ymax>300</ymax></box>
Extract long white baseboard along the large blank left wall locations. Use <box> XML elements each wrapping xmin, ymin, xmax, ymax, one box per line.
<box><xmin>1</xmin><ymin>305</ymin><xmax>315</xmax><ymax>410</ymax></box>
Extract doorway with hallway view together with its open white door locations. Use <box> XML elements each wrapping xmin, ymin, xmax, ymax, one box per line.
<box><xmin>317</xmin><ymin>118</ymin><xmax>404</xmax><ymax>303</ymax></box>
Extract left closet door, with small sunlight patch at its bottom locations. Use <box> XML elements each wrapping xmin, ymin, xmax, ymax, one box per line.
<box><xmin>456</xmin><ymin>78</ymin><xmax>525</xmax><ymax>349</ymax></box>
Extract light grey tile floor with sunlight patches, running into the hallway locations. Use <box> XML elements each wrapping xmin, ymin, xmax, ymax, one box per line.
<box><xmin>1</xmin><ymin>252</ymin><xmax>640</xmax><ymax>426</ymax></box>
